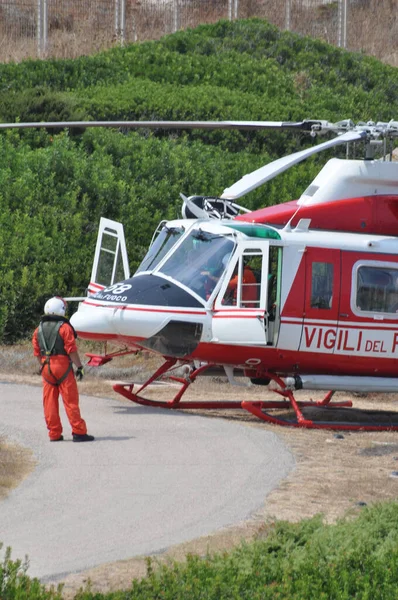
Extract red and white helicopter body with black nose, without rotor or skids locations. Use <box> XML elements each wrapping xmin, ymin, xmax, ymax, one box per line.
<box><xmin>72</xmin><ymin>213</ymin><xmax>398</xmax><ymax>386</ymax></box>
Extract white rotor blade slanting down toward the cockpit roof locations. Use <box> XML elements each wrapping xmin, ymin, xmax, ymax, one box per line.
<box><xmin>220</xmin><ymin>131</ymin><xmax>367</xmax><ymax>200</ymax></box>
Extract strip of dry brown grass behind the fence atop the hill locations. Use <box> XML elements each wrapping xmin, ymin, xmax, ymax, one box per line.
<box><xmin>0</xmin><ymin>0</ymin><xmax>398</xmax><ymax>66</ymax></box>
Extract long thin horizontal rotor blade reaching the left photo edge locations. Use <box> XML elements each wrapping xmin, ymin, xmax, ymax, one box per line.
<box><xmin>0</xmin><ymin>121</ymin><xmax>321</xmax><ymax>131</ymax></box>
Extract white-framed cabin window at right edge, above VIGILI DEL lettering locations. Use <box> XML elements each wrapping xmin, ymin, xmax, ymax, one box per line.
<box><xmin>356</xmin><ymin>266</ymin><xmax>398</xmax><ymax>314</ymax></box>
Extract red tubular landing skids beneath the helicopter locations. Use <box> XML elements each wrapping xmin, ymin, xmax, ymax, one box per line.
<box><xmin>113</xmin><ymin>359</ymin><xmax>398</xmax><ymax>431</ymax></box>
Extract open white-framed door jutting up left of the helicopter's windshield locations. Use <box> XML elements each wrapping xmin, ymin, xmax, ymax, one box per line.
<box><xmin>88</xmin><ymin>217</ymin><xmax>130</xmax><ymax>295</ymax></box>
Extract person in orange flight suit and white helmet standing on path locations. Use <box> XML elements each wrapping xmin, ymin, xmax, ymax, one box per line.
<box><xmin>32</xmin><ymin>297</ymin><xmax>94</xmax><ymax>442</ymax></box>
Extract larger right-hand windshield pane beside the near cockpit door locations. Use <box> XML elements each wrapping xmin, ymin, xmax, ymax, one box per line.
<box><xmin>160</xmin><ymin>229</ymin><xmax>235</xmax><ymax>300</ymax></box>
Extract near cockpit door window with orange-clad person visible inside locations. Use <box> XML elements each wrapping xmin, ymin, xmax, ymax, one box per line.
<box><xmin>222</xmin><ymin>249</ymin><xmax>263</xmax><ymax>308</ymax></box>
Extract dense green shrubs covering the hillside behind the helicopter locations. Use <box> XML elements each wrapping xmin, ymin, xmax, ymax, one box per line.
<box><xmin>0</xmin><ymin>19</ymin><xmax>398</xmax><ymax>343</ymax></box>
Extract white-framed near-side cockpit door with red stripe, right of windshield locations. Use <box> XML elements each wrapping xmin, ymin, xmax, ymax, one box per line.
<box><xmin>212</xmin><ymin>240</ymin><xmax>269</xmax><ymax>346</ymax></box>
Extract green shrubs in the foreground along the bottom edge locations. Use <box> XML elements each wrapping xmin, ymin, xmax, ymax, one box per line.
<box><xmin>0</xmin><ymin>502</ymin><xmax>398</xmax><ymax>600</ymax></box>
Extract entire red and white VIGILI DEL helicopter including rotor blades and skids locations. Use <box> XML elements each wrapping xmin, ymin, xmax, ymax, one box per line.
<box><xmin>0</xmin><ymin>120</ymin><xmax>398</xmax><ymax>430</ymax></box>
